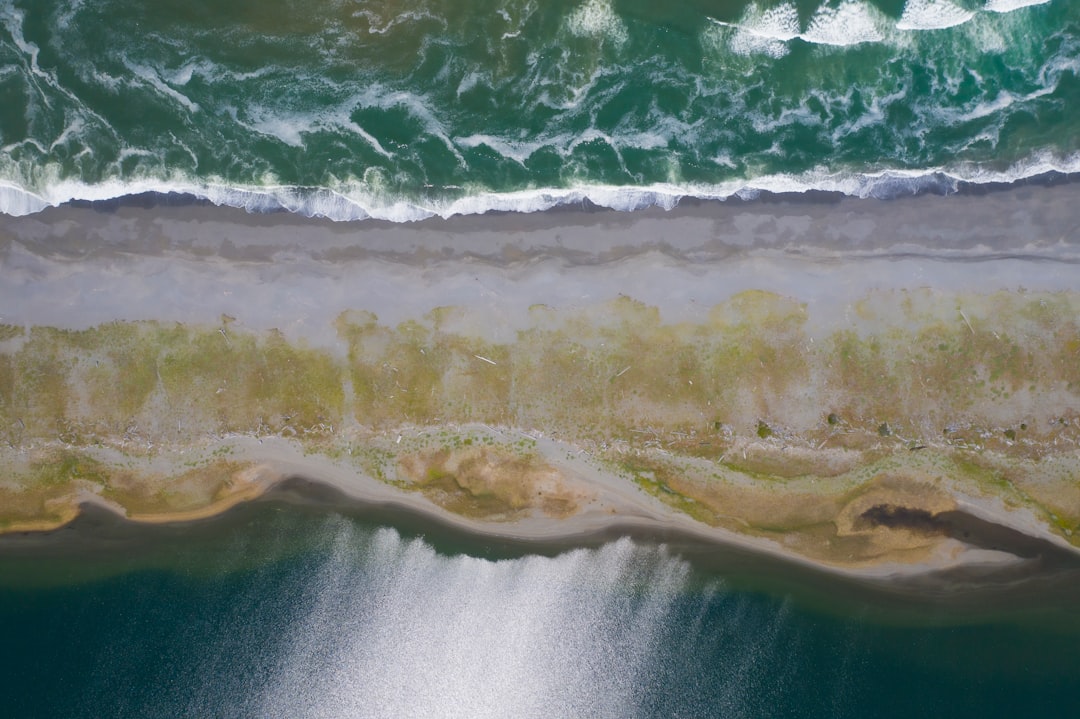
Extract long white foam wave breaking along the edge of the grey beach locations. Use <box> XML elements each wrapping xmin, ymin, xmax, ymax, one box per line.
<box><xmin>0</xmin><ymin>164</ymin><xmax>1080</xmax><ymax>223</ymax></box>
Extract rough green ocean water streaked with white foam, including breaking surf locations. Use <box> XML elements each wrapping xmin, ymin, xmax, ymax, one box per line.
<box><xmin>0</xmin><ymin>0</ymin><xmax>1080</xmax><ymax>221</ymax></box>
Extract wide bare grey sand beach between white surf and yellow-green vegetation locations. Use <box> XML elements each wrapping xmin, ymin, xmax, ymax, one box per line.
<box><xmin>0</xmin><ymin>184</ymin><xmax>1080</xmax><ymax>345</ymax></box>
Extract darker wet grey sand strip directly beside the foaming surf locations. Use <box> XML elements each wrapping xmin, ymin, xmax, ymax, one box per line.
<box><xmin>8</xmin><ymin>181</ymin><xmax>1080</xmax><ymax>264</ymax></box>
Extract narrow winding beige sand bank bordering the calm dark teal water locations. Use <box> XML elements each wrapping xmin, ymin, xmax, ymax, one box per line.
<box><xmin>0</xmin><ymin>425</ymin><xmax>1080</xmax><ymax>601</ymax></box>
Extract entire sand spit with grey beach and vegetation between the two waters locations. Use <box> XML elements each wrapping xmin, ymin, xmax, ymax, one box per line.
<box><xmin>0</xmin><ymin>192</ymin><xmax>1080</xmax><ymax>578</ymax></box>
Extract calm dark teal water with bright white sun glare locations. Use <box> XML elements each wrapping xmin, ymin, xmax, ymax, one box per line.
<box><xmin>0</xmin><ymin>507</ymin><xmax>1080</xmax><ymax>718</ymax></box>
